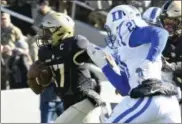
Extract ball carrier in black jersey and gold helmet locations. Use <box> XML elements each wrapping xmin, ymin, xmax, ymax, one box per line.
<box><xmin>29</xmin><ymin>13</ymin><xmax>105</xmax><ymax>123</ymax></box>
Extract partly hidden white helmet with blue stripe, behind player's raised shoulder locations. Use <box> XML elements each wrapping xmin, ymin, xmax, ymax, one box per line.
<box><xmin>142</xmin><ymin>7</ymin><xmax>161</xmax><ymax>26</ymax></box>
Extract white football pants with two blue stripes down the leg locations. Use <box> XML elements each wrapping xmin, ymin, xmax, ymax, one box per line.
<box><xmin>106</xmin><ymin>96</ymin><xmax>181</xmax><ymax>124</ymax></box>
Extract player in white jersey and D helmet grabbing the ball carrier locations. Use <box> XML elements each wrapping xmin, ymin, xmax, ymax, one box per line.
<box><xmin>87</xmin><ymin>5</ymin><xmax>181</xmax><ymax>123</ymax></box>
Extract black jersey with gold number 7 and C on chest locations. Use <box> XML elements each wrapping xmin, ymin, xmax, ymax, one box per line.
<box><xmin>38</xmin><ymin>35</ymin><xmax>100</xmax><ymax>108</ymax></box>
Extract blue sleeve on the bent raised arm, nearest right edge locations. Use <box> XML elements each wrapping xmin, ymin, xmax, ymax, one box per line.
<box><xmin>129</xmin><ymin>26</ymin><xmax>169</xmax><ymax>61</ymax></box>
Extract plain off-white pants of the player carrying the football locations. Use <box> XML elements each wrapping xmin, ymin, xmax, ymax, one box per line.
<box><xmin>54</xmin><ymin>99</ymin><xmax>102</xmax><ymax>124</ymax></box>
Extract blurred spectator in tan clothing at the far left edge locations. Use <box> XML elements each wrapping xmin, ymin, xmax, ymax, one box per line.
<box><xmin>1</xmin><ymin>13</ymin><xmax>28</xmax><ymax>86</ymax></box>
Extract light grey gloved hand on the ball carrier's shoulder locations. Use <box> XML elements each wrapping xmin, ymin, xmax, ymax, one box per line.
<box><xmin>76</xmin><ymin>35</ymin><xmax>89</xmax><ymax>49</ymax></box>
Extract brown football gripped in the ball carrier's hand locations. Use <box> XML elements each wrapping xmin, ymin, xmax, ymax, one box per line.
<box><xmin>27</xmin><ymin>61</ymin><xmax>52</xmax><ymax>94</ymax></box>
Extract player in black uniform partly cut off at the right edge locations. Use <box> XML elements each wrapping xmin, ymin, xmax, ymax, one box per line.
<box><xmin>160</xmin><ymin>0</ymin><xmax>182</xmax><ymax>92</ymax></box>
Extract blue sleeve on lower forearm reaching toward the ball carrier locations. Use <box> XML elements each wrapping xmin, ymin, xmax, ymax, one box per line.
<box><xmin>102</xmin><ymin>65</ymin><xmax>130</xmax><ymax>96</ymax></box>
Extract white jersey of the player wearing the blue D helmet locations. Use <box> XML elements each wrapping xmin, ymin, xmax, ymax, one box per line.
<box><xmin>115</xmin><ymin>18</ymin><xmax>162</xmax><ymax>89</ymax></box>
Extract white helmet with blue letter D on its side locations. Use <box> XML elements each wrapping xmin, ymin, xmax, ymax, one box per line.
<box><xmin>105</xmin><ymin>5</ymin><xmax>141</xmax><ymax>49</ymax></box>
